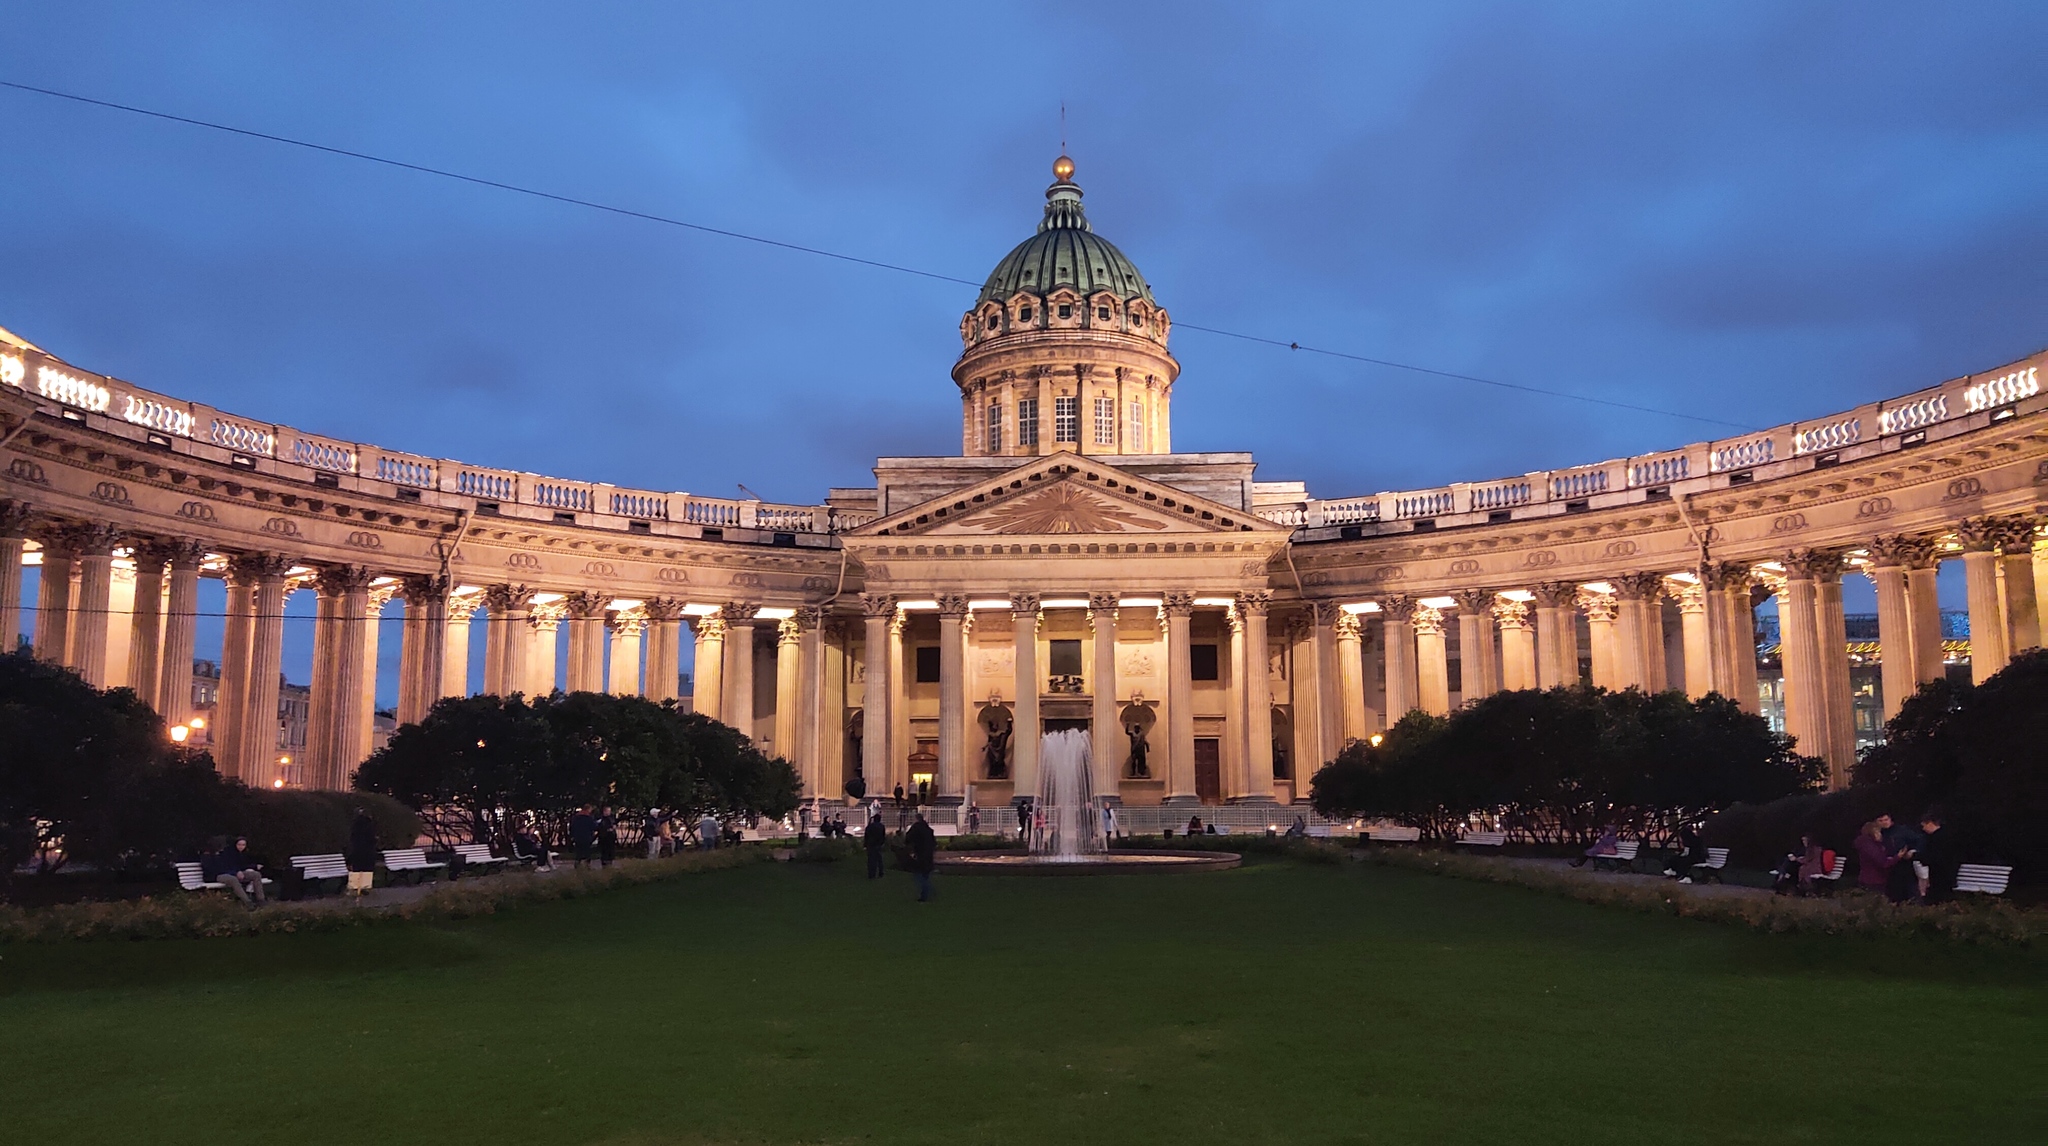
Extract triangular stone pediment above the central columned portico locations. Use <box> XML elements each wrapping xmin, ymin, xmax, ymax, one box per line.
<box><xmin>856</xmin><ymin>452</ymin><xmax>1288</xmax><ymax>538</ymax></box>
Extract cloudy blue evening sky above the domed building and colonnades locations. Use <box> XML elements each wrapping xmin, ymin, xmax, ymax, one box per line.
<box><xmin>0</xmin><ymin>2</ymin><xmax>2048</xmax><ymax>692</ymax></box>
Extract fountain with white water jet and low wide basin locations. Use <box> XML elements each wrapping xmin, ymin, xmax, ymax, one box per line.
<box><xmin>938</xmin><ymin>729</ymin><xmax>1241</xmax><ymax>876</ymax></box>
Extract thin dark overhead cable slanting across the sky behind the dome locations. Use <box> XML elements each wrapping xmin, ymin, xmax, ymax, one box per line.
<box><xmin>0</xmin><ymin>80</ymin><xmax>1749</xmax><ymax>430</ymax></box>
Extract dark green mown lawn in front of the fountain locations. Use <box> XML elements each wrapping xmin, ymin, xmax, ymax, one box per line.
<box><xmin>0</xmin><ymin>862</ymin><xmax>2048</xmax><ymax>1146</ymax></box>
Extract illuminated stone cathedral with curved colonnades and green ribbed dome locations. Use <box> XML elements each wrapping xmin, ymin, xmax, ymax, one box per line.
<box><xmin>0</xmin><ymin>168</ymin><xmax>2048</xmax><ymax>808</ymax></box>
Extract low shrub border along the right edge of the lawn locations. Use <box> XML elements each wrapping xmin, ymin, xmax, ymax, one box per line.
<box><xmin>1352</xmin><ymin>847</ymin><xmax>2048</xmax><ymax>947</ymax></box>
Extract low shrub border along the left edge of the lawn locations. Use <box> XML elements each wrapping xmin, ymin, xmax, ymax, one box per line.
<box><xmin>0</xmin><ymin>847</ymin><xmax>772</xmax><ymax>943</ymax></box>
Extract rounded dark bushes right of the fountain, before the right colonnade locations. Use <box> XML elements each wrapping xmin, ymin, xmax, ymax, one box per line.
<box><xmin>1311</xmin><ymin>688</ymin><xmax>1821</xmax><ymax>843</ymax></box>
